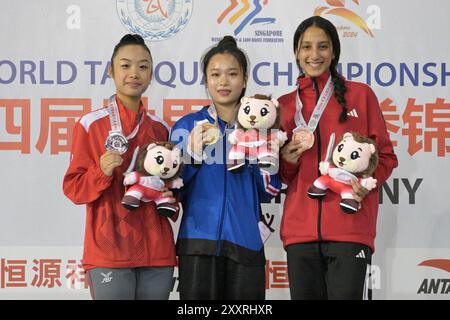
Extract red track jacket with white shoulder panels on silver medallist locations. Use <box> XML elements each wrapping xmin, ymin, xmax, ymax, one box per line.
<box><xmin>63</xmin><ymin>99</ymin><xmax>176</xmax><ymax>269</ymax></box>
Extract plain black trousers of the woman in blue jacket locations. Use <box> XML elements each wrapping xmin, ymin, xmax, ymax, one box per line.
<box><xmin>178</xmin><ymin>256</ymin><xmax>266</xmax><ymax>300</ymax></box>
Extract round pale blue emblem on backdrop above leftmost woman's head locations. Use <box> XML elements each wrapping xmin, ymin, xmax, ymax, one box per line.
<box><xmin>116</xmin><ymin>0</ymin><xmax>194</xmax><ymax>41</ymax></box>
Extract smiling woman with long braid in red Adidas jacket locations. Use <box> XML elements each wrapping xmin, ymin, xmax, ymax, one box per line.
<box><xmin>279</xmin><ymin>16</ymin><xmax>397</xmax><ymax>299</ymax></box>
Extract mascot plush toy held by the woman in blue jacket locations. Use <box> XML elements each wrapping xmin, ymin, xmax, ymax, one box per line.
<box><xmin>228</xmin><ymin>94</ymin><xmax>287</xmax><ymax>172</ymax></box>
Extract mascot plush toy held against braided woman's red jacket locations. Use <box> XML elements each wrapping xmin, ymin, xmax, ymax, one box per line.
<box><xmin>308</xmin><ymin>132</ymin><xmax>378</xmax><ymax>213</ymax></box>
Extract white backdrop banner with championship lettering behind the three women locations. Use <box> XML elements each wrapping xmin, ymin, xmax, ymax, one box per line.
<box><xmin>0</xmin><ymin>0</ymin><xmax>450</xmax><ymax>300</ymax></box>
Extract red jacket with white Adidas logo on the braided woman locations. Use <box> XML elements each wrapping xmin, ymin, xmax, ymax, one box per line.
<box><xmin>279</xmin><ymin>73</ymin><xmax>398</xmax><ymax>251</ymax></box>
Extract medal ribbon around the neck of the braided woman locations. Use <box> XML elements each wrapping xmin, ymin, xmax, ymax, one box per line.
<box><xmin>292</xmin><ymin>76</ymin><xmax>334</xmax><ymax>132</ymax></box>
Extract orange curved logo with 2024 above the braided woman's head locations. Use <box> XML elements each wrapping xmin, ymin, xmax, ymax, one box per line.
<box><xmin>313</xmin><ymin>0</ymin><xmax>381</xmax><ymax>38</ymax></box>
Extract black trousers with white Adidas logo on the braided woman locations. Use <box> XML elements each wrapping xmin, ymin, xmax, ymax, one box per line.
<box><xmin>286</xmin><ymin>242</ymin><xmax>372</xmax><ymax>300</ymax></box>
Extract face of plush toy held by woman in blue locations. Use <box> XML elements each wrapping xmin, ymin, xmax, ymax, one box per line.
<box><xmin>237</xmin><ymin>97</ymin><xmax>278</xmax><ymax>129</ymax></box>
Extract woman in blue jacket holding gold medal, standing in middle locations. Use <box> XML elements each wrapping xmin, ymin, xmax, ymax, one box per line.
<box><xmin>171</xmin><ymin>36</ymin><xmax>281</xmax><ymax>300</ymax></box>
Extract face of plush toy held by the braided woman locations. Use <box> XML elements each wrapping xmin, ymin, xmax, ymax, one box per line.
<box><xmin>333</xmin><ymin>133</ymin><xmax>375</xmax><ymax>173</ymax></box>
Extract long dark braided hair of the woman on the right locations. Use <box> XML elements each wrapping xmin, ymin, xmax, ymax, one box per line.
<box><xmin>294</xmin><ymin>16</ymin><xmax>347</xmax><ymax>122</ymax></box>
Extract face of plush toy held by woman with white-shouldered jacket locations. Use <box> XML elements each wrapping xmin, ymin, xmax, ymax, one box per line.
<box><xmin>144</xmin><ymin>144</ymin><xmax>181</xmax><ymax>179</ymax></box>
